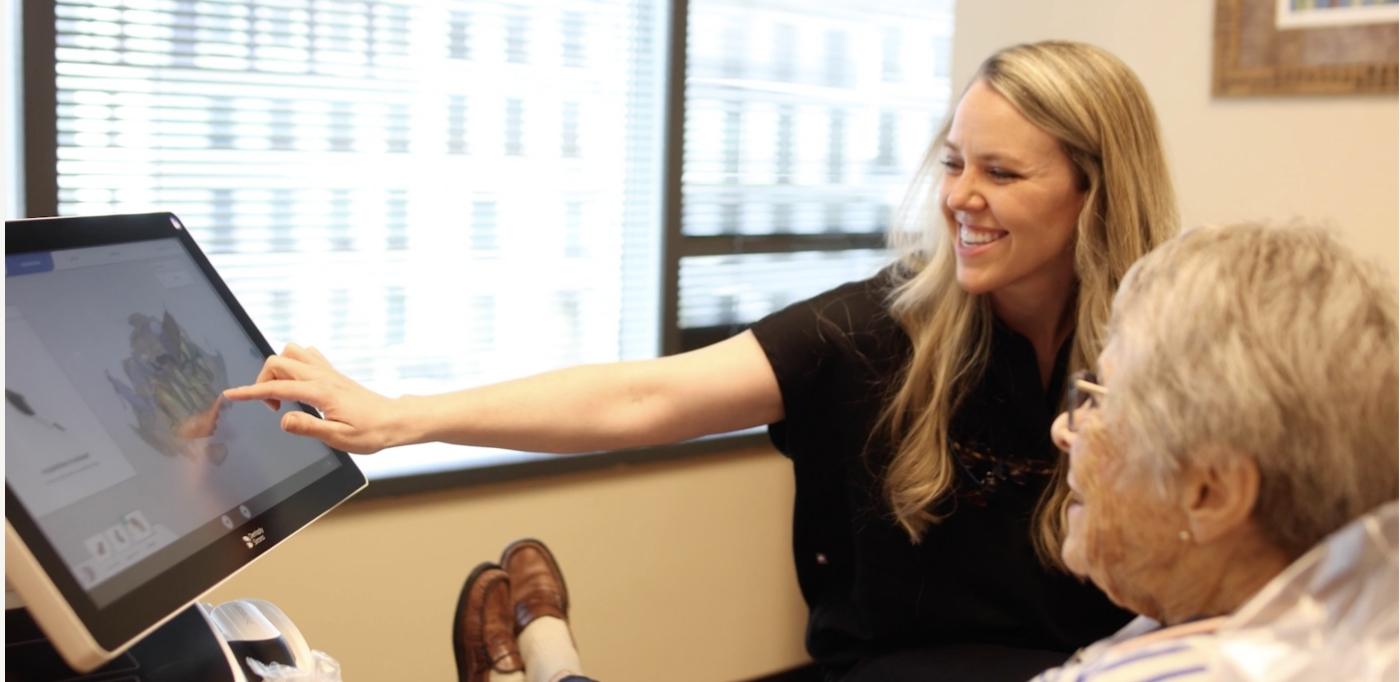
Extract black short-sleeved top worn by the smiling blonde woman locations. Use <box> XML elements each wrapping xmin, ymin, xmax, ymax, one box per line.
<box><xmin>752</xmin><ymin>272</ymin><xmax>1130</xmax><ymax>671</ymax></box>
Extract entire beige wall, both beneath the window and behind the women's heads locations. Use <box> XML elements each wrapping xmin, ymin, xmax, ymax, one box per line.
<box><xmin>213</xmin><ymin>0</ymin><xmax>1397</xmax><ymax>682</ymax></box>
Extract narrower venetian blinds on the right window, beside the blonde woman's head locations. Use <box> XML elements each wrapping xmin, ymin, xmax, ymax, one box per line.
<box><xmin>678</xmin><ymin>0</ymin><xmax>953</xmax><ymax>346</ymax></box>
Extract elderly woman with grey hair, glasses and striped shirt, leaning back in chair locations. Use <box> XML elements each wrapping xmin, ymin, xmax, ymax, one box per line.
<box><xmin>1042</xmin><ymin>225</ymin><xmax>1397</xmax><ymax>681</ymax></box>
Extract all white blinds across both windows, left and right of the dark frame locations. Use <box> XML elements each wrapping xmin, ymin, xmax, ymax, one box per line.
<box><xmin>43</xmin><ymin>0</ymin><xmax>952</xmax><ymax>476</ymax></box>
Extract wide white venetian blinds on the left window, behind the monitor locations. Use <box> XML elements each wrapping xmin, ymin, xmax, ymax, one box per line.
<box><xmin>55</xmin><ymin>0</ymin><xmax>666</xmax><ymax>476</ymax></box>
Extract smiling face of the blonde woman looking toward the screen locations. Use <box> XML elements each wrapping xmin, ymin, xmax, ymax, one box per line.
<box><xmin>938</xmin><ymin>81</ymin><xmax>1084</xmax><ymax>301</ymax></box>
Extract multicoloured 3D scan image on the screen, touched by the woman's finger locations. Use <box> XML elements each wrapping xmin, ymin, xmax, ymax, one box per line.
<box><xmin>106</xmin><ymin>311</ymin><xmax>228</xmax><ymax>465</ymax></box>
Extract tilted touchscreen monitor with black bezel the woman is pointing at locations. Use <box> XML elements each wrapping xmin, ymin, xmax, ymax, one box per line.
<box><xmin>4</xmin><ymin>213</ymin><xmax>365</xmax><ymax>671</ymax></box>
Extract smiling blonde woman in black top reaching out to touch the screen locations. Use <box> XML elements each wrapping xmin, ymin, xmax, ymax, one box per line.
<box><xmin>227</xmin><ymin>42</ymin><xmax>1176</xmax><ymax>679</ymax></box>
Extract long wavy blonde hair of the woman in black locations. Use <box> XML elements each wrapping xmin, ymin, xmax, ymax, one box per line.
<box><xmin>882</xmin><ymin>41</ymin><xmax>1177</xmax><ymax>563</ymax></box>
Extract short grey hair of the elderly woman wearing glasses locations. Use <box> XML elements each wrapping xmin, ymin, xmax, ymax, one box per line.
<box><xmin>1105</xmin><ymin>224</ymin><xmax>1400</xmax><ymax>556</ymax></box>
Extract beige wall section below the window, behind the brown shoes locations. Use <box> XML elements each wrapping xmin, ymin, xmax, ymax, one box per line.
<box><xmin>207</xmin><ymin>450</ymin><xmax>805</xmax><ymax>682</ymax></box>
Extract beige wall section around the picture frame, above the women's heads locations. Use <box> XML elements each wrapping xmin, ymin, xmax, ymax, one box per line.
<box><xmin>953</xmin><ymin>0</ymin><xmax>1400</xmax><ymax>272</ymax></box>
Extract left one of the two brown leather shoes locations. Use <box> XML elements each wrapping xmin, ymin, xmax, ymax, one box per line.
<box><xmin>452</xmin><ymin>563</ymin><xmax>525</xmax><ymax>682</ymax></box>
